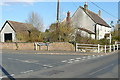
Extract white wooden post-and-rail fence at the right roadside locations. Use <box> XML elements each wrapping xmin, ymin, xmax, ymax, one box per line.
<box><xmin>75</xmin><ymin>43</ymin><xmax>120</xmax><ymax>53</ymax></box>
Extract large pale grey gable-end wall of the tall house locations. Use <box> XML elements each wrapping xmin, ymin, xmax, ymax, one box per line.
<box><xmin>71</xmin><ymin>8</ymin><xmax>95</xmax><ymax>32</ymax></box>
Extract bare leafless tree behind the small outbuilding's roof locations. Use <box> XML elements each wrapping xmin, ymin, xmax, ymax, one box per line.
<box><xmin>25</xmin><ymin>12</ymin><xmax>43</xmax><ymax>31</ymax></box>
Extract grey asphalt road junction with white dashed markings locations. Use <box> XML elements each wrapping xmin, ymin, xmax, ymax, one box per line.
<box><xmin>2</xmin><ymin>51</ymin><xmax>118</xmax><ymax>78</ymax></box>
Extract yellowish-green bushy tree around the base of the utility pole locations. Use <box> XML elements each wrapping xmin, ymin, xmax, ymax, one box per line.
<box><xmin>46</xmin><ymin>23</ymin><xmax>74</xmax><ymax>42</ymax></box>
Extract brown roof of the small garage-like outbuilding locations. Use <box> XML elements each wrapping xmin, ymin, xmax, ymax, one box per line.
<box><xmin>1</xmin><ymin>20</ymin><xmax>35</xmax><ymax>32</ymax></box>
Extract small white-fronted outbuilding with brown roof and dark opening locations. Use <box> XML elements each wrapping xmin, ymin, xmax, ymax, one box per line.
<box><xmin>0</xmin><ymin>20</ymin><xmax>37</xmax><ymax>42</ymax></box>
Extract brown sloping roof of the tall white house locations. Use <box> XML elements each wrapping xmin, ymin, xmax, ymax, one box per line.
<box><xmin>80</xmin><ymin>6</ymin><xmax>110</xmax><ymax>27</ymax></box>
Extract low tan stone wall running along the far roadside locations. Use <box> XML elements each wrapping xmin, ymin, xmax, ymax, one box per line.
<box><xmin>0</xmin><ymin>42</ymin><xmax>74</xmax><ymax>51</ymax></box>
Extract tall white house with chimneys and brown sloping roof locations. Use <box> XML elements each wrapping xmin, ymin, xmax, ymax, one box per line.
<box><xmin>63</xmin><ymin>3</ymin><xmax>111</xmax><ymax>40</ymax></box>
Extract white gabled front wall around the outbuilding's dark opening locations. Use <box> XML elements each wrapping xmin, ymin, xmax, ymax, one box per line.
<box><xmin>0</xmin><ymin>23</ymin><xmax>16</xmax><ymax>42</ymax></box>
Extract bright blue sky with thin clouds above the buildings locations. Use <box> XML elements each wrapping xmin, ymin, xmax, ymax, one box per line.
<box><xmin>0</xmin><ymin>2</ymin><xmax>118</xmax><ymax>30</ymax></box>
